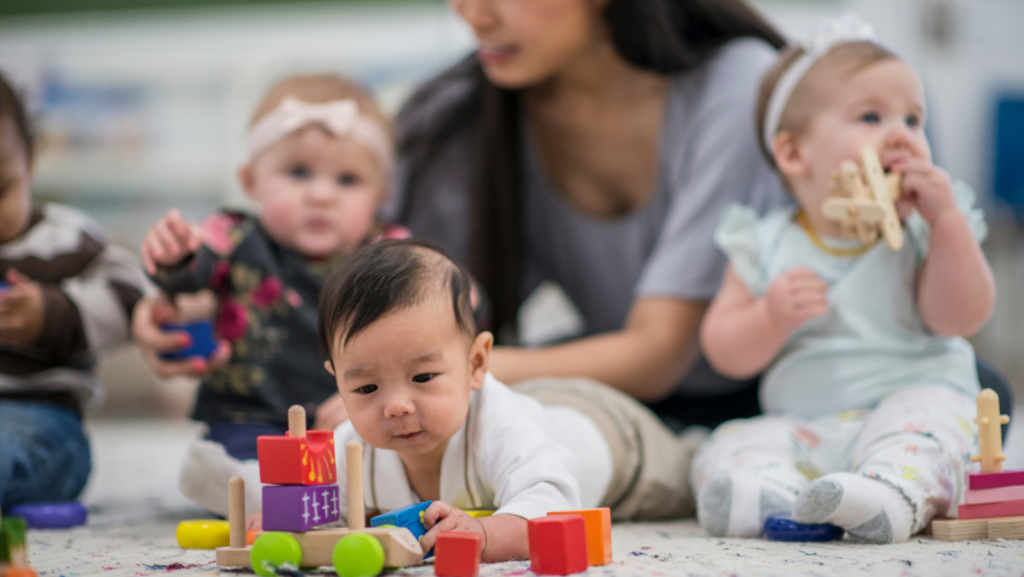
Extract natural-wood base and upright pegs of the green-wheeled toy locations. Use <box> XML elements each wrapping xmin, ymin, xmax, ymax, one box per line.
<box><xmin>217</xmin><ymin>406</ymin><xmax>423</xmax><ymax>575</ymax></box>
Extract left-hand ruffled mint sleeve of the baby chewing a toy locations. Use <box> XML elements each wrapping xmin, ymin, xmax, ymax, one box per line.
<box><xmin>715</xmin><ymin>204</ymin><xmax>766</xmax><ymax>298</ymax></box>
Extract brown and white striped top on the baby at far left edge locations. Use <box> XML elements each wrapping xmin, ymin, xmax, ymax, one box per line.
<box><xmin>0</xmin><ymin>204</ymin><xmax>144</xmax><ymax>409</ymax></box>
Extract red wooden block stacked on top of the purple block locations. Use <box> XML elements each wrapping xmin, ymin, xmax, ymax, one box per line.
<box><xmin>256</xmin><ymin>430</ymin><xmax>338</xmax><ymax>485</ymax></box>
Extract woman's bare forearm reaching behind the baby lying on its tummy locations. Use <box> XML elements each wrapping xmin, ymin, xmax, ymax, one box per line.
<box><xmin>490</xmin><ymin>296</ymin><xmax>708</xmax><ymax>402</ymax></box>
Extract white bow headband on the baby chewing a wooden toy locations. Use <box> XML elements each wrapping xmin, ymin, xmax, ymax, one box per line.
<box><xmin>764</xmin><ymin>13</ymin><xmax>879</xmax><ymax>155</ymax></box>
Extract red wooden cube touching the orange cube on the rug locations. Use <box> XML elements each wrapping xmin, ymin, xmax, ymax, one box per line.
<box><xmin>526</xmin><ymin>514</ymin><xmax>587</xmax><ymax>575</ymax></box>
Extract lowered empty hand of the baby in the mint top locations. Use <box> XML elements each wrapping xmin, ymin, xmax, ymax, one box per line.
<box><xmin>765</xmin><ymin>269</ymin><xmax>828</xmax><ymax>334</ymax></box>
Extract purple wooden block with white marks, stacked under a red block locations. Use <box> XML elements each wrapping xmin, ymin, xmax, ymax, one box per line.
<box><xmin>263</xmin><ymin>485</ymin><xmax>341</xmax><ymax>533</ymax></box>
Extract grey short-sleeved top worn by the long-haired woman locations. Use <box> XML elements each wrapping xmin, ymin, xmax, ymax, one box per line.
<box><xmin>392</xmin><ymin>39</ymin><xmax>785</xmax><ymax>393</ymax></box>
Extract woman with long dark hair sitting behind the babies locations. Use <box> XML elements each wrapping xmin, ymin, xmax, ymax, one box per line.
<box><xmin>395</xmin><ymin>0</ymin><xmax>783</xmax><ymax>424</ymax></box>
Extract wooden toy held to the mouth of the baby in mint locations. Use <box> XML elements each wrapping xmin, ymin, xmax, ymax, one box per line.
<box><xmin>821</xmin><ymin>147</ymin><xmax>903</xmax><ymax>250</ymax></box>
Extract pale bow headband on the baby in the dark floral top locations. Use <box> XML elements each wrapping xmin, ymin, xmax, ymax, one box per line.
<box><xmin>249</xmin><ymin>96</ymin><xmax>392</xmax><ymax>173</ymax></box>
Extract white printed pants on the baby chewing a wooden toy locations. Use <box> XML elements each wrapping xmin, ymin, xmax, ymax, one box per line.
<box><xmin>690</xmin><ymin>386</ymin><xmax>976</xmax><ymax>534</ymax></box>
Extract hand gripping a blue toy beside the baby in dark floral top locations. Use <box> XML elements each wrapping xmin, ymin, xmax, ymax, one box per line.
<box><xmin>132</xmin><ymin>295</ymin><xmax>231</xmax><ymax>378</ymax></box>
